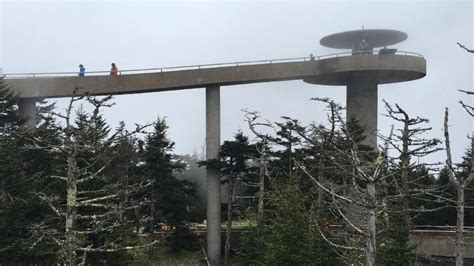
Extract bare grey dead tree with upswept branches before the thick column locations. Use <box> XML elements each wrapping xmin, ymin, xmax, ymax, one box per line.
<box><xmin>298</xmin><ymin>99</ymin><xmax>393</xmax><ymax>265</ymax></box>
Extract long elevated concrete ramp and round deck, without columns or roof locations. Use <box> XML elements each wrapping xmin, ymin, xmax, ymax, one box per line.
<box><xmin>7</xmin><ymin>55</ymin><xmax>426</xmax><ymax>98</ymax></box>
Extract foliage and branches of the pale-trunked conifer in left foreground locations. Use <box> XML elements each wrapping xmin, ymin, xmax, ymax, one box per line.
<box><xmin>25</xmin><ymin>97</ymin><xmax>154</xmax><ymax>265</ymax></box>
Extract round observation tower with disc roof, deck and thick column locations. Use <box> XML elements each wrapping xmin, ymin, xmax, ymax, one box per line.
<box><xmin>303</xmin><ymin>29</ymin><xmax>426</xmax><ymax>147</ymax></box>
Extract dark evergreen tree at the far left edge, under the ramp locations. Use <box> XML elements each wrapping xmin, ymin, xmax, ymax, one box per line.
<box><xmin>0</xmin><ymin>77</ymin><xmax>60</xmax><ymax>263</ymax></box>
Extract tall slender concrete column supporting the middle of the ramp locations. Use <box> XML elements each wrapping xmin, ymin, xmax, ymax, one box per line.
<box><xmin>206</xmin><ymin>86</ymin><xmax>221</xmax><ymax>266</ymax></box>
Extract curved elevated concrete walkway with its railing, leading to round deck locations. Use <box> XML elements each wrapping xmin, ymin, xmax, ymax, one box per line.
<box><xmin>4</xmin><ymin>49</ymin><xmax>426</xmax><ymax>98</ymax></box>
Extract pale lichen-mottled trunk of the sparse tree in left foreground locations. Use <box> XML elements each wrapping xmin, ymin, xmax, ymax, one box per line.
<box><xmin>64</xmin><ymin>155</ymin><xmax>77</xmax><ymax>265</ymax></box>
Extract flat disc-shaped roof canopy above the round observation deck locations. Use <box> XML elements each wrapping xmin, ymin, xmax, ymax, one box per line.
<box><xmin>319</xmin><ymin>29</ymin><xmax>408</xmax><ymax>50</ymax></box>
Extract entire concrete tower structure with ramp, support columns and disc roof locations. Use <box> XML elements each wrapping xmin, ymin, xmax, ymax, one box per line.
<box><xmin>5</xmin><ymin>30</ymin><xmax>426</xmax><ymax>265</ymax></box>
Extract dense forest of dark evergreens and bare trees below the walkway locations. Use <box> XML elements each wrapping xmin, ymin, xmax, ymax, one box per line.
<box><xmin>0</xmin><ymin>47</ymin><xmax>474</xmax><ymax>265</ymax></box>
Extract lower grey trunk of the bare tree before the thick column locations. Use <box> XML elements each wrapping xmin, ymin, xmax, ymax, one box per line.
<box><xmin>365</xmin><ymin>181</ymin><xmax>376</xmax><ymax>266</ymax></box>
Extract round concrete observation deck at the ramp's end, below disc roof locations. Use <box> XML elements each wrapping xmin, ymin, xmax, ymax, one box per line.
<box><xmin>303</xmin><ymin>52</ymin><xmax>426</xmax><ymax>86</ymax></box>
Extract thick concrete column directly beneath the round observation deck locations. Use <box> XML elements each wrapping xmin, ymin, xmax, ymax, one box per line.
<box><xmin>346</xmin><ymin>77</ymin><xmax>378</xmax><ymax>149</ymax></box>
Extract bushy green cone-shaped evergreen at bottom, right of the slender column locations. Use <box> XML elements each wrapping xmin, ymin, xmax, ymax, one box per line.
<box><xmin>239</xmin><ymin>177</ymin><xmax>336</xmax><ymax>265</ymax></box>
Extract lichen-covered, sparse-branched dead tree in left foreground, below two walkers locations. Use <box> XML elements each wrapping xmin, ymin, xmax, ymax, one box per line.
<box><xmin>29</xmin><ymin>93</ymin><xmax>158</xmax><ymax>265</ymax></box>
